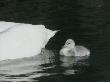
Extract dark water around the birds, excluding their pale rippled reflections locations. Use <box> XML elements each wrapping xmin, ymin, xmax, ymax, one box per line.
<box><xmin>0</xmin><ymin>0</ymin><xmax>110</xmax><ymax>82</ymax></box>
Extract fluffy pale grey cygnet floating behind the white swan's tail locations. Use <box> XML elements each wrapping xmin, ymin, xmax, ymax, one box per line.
<box><xmin>59</xmin><ymin>39</ymin><xmax>90</xmax><ymax>56</ymax></box>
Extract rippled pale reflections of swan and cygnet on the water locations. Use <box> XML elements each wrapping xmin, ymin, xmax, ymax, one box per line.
<box><xmin>0</xmin><ymin>50</ymin><xmax>89</xmax><ymax>82</ymax></box>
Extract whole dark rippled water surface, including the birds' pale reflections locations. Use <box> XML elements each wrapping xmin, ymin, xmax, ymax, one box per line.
<box><xmin>0</xmin><ymin>0</ymin><xmax>110</xmax><ymax>82</ymax></box>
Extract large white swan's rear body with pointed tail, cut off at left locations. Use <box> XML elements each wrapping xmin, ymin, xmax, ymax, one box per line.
<box><xmin>0</xmin><ymin>21</ymin><xmax>57</xmax><ymax>60</ymax></box>
